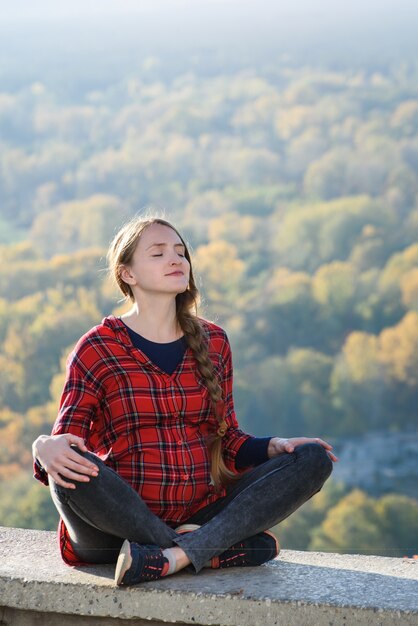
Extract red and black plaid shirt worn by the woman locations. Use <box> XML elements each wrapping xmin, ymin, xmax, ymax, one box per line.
<box><xmin>35</xmin><ymin>316</ymin><xmax>250</xmax><ymax>564</ymax></box>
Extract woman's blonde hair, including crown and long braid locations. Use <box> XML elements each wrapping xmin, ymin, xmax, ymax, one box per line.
<box><xmin>107</xmin><ymin>217</ymin><xmax>236</xmax><ymax>489</ymax></box>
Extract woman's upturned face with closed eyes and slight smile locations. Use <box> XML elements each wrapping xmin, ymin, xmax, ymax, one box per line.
<box><xmin>121</xmin><ymin>224</ymin><xmax>190</xmax><ymax>298</ymax></box>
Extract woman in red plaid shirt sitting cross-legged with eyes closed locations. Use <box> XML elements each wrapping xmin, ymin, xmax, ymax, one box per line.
<box><xmin>33</xmin><ymin>218</ymin><xmax>336</xmax><ymax>585</ymax></box>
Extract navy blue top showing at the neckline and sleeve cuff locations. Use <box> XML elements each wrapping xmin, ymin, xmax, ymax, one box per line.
<box><xmin>122</xmin><ymin>320</ymin><xmax>271</xmax><ymax>470</ymax></box>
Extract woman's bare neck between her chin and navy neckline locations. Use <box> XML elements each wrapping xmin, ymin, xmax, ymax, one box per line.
<box><xmin>122</xmin><ymin>298</ymin><xmax>183</xmax><ymax>343</ymax></box>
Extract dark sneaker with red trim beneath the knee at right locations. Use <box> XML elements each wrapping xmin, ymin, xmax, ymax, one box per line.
<box><xmin>176</xmin><ymin>524</ymin><xmax>280</xmax><ymax>569</ymax></box>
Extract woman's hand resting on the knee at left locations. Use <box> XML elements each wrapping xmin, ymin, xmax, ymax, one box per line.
<box><xmin>32</xmin><ymin>433</ymin><xmax>99</xmax><ymax>489</ymax></box>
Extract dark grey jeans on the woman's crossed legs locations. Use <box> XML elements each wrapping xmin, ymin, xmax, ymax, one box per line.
<box><xmin>50</xmin><ymin>443</ymin><xmax>332</xmax><ymax>572</ymax></box>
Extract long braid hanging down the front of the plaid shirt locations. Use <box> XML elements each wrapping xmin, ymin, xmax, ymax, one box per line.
<box><xmin>177</xmin><ymin>307</ymin><xmax>236</xmax><ymax>488</ymax></box>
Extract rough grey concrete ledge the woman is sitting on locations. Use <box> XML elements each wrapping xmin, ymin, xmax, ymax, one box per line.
<box><xmin>0</xmin><ymin>528</ymin><xmax>418</xmax><ymax>626</ymax></box>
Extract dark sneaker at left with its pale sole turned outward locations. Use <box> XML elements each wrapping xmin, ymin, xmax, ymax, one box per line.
<box><xmin>115</xmin><ymin>539</ymin><xmax>169</xmax><ymax>586</ymax></box>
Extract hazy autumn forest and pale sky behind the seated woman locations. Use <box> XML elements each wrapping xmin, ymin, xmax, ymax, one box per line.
<box><xmin>0</xmin><ymin>0</ymin><xmax>418</xmax><ymax>556</ymax></box>
